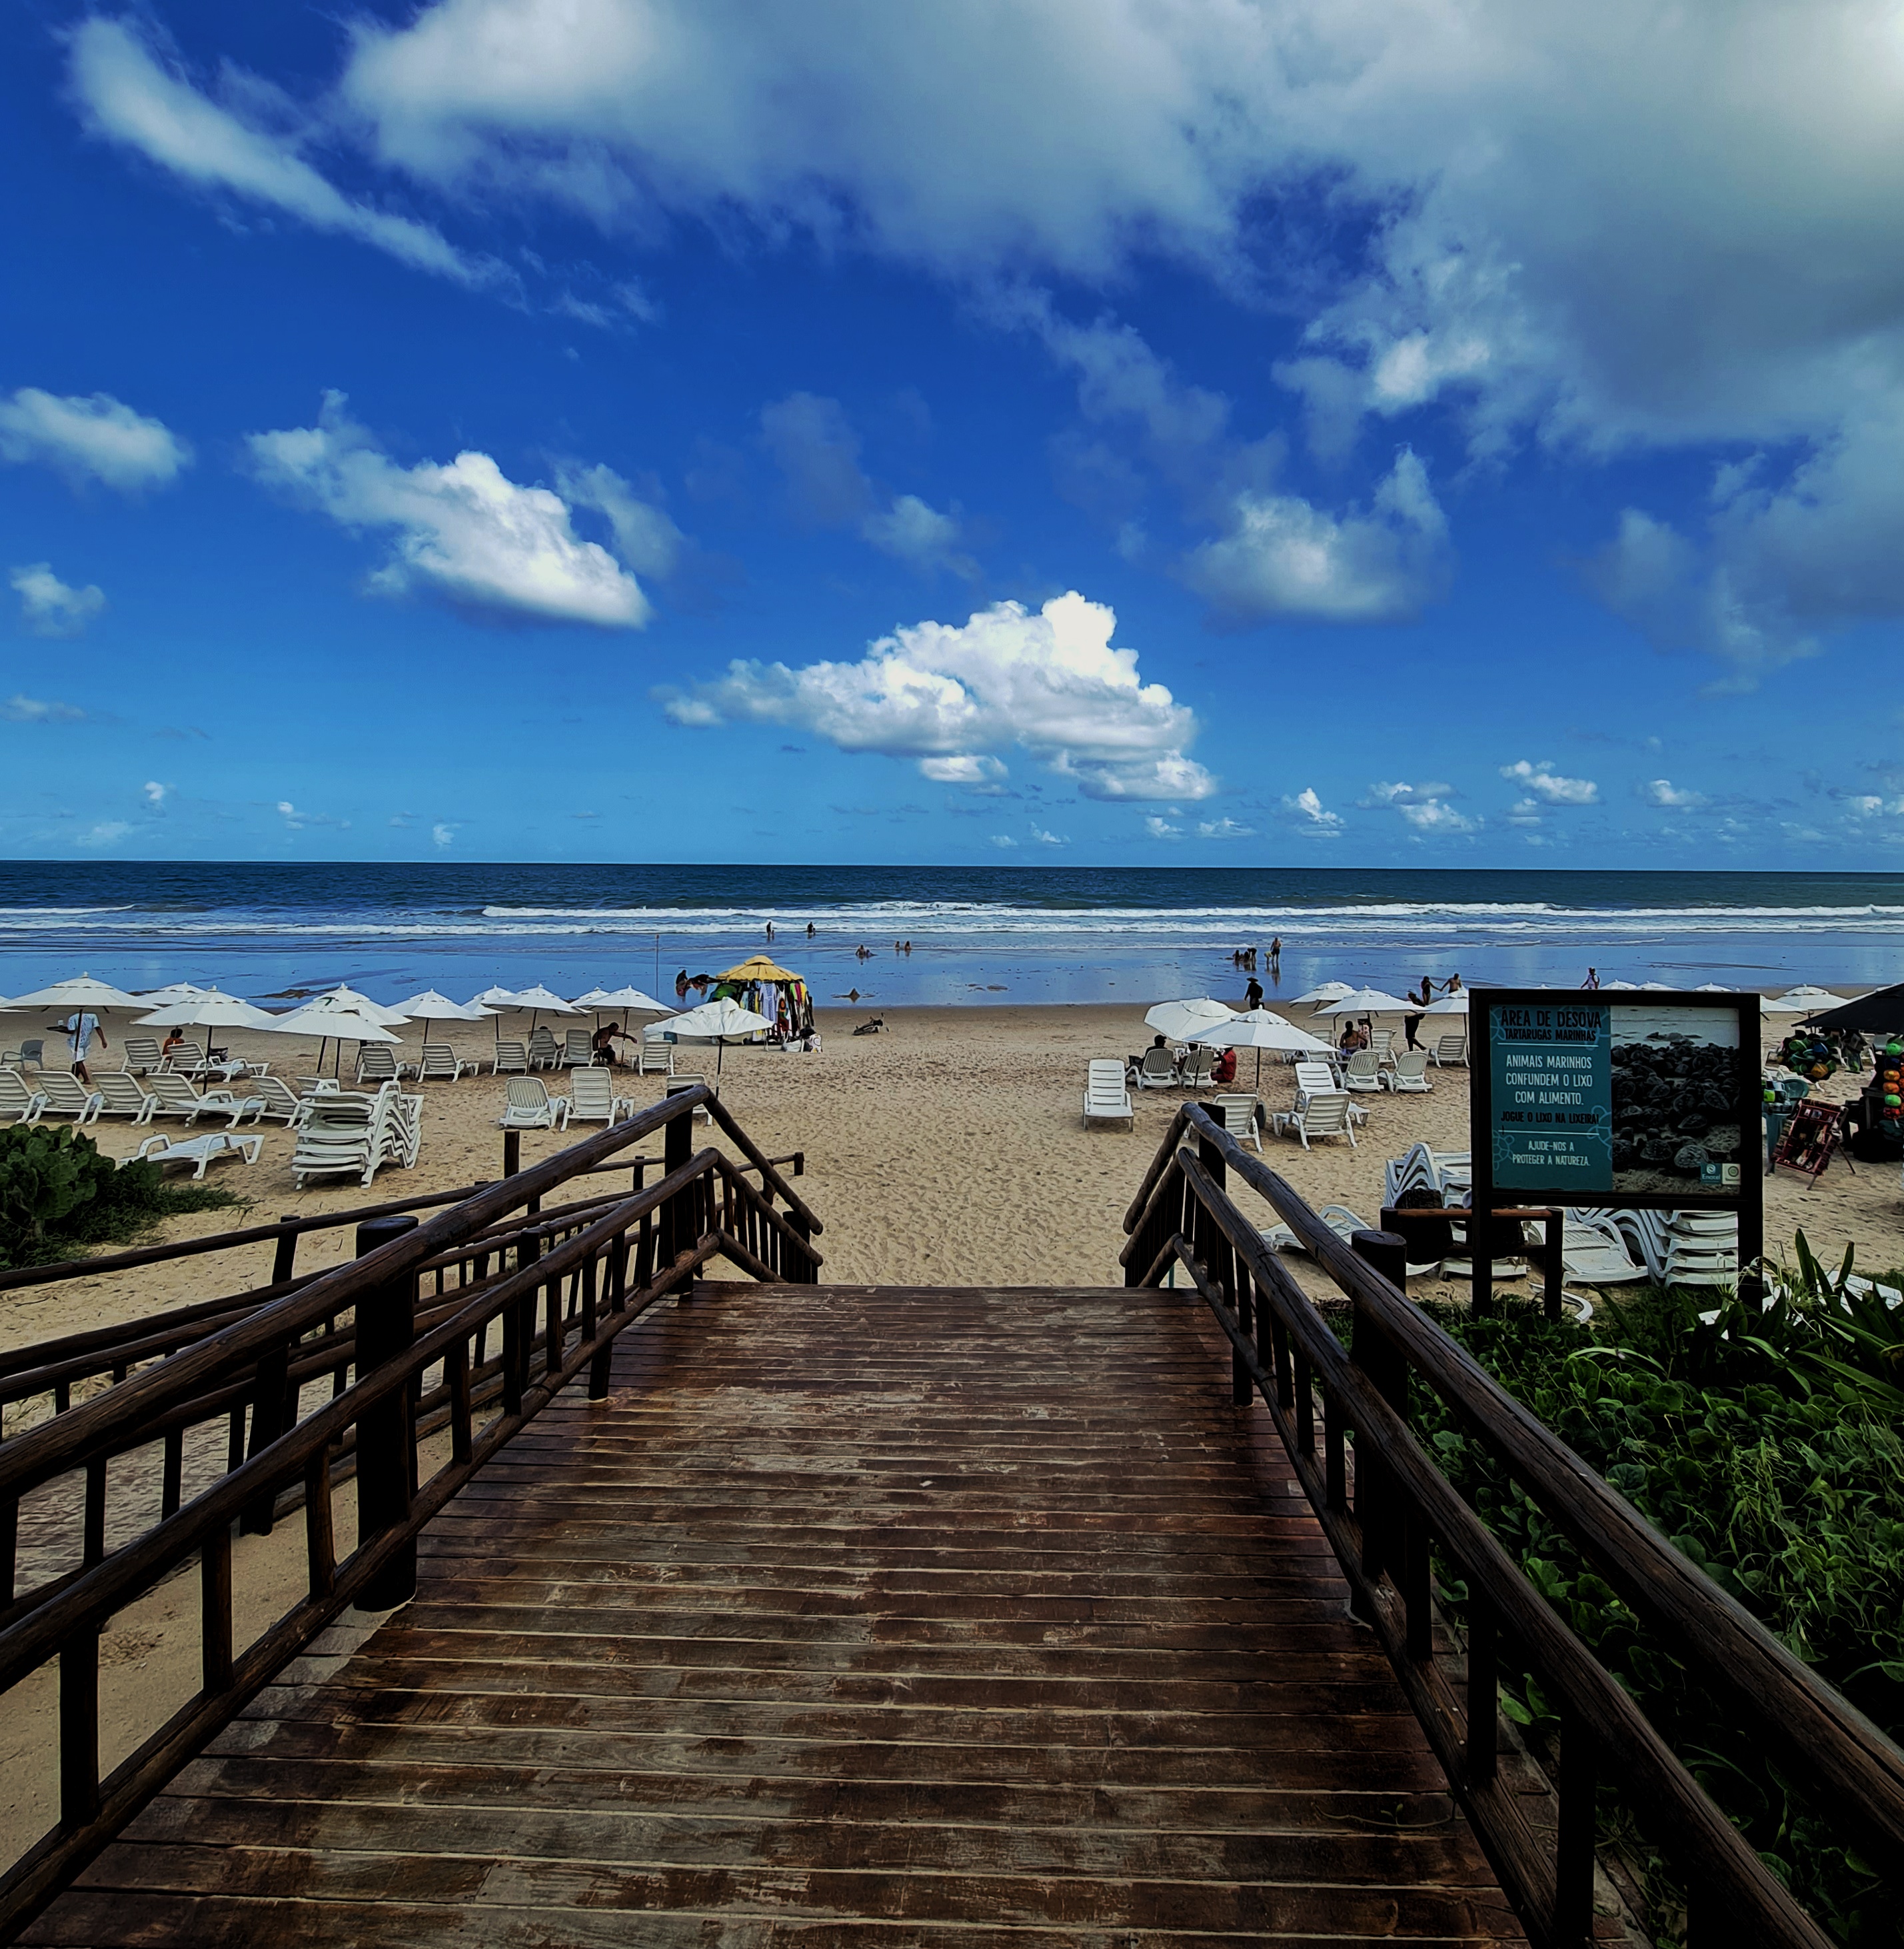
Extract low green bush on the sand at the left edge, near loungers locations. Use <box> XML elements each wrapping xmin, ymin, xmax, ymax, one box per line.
<box><xmin>0</xmin><ymin>1124</ymin><xmax>238</xmax><ymax>1267</ymax></box>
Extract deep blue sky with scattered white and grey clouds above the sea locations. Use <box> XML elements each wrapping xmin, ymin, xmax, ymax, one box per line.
<box><xmin>0</xmin><ymin>0</ymin><xmax>1904</xmax><ymax>869</ymax></box>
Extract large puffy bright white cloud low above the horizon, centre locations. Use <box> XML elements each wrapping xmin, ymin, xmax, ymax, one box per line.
<box><xmin>662</xmin><ymin>593</ymin><xmax>1216</xmax><ymax>801</ymax></box>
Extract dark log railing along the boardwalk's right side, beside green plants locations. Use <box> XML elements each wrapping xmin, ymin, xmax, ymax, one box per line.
<box><xmin>1122</xmin><ymin>1105</ymin><xmax>1904</xmax><ymax>1949</ymax></box>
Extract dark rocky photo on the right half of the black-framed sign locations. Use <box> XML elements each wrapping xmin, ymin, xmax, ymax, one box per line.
<box><xmin>1611</xmin><ymin>1004</ymin><xmax>1758</xmax><ymax>1196</ymax></box>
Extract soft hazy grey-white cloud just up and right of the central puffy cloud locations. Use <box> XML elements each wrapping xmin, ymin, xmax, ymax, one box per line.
<box><xmin>1185</xmin><ymin>449</ymin><xmax>1448</xmax><ymax>622</ymax></box>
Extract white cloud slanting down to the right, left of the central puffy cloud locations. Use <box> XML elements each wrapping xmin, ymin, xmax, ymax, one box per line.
<box><xmin>247</xmin><ymin>392</ymin><xmax>653</xmax><ymax>629</ymax></box>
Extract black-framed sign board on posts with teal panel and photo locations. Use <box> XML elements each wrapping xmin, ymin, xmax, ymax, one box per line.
<box><xmin>1467</xmin><ymin>988</ymin><xmax>1765</xmax><ymax>1314</ymax></box>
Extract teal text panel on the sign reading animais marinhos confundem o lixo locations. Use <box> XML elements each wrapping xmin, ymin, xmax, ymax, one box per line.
<box><xmin>1487</xmin><ymin>1002</ymin><xmax>1613</xmax><ymax>1204</ymax></box>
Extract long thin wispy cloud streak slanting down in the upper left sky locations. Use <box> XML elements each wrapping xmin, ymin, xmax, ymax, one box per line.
<box><xmin>72</xmin><ymin>13</ymin><xmax>499</xmax><ymax>285</ymax></box>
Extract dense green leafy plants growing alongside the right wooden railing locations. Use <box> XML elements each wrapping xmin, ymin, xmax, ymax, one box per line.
<box><xmin>1380</xmin><ymin>1270</ymin><xmax>1904</xmax><ymax>1949</ymax></box>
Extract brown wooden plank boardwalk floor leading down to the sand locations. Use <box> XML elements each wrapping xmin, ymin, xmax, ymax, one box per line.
<box><xmin>23</xmin><ymin>1286</ymin><xmax>1520</xmax><ymax>1949</ymax></box>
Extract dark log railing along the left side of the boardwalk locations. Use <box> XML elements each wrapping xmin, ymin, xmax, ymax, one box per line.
<box><xmin>0</xmin><ymin>1088</ymin><xmax>820</xmax><ymax>1939</ymax></box>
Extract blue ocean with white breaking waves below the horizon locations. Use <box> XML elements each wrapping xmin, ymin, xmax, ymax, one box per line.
<box><xmin>0</xmin><ymin>859</ymin><xmax>1904</xmax><ymax>1006</ymax></box>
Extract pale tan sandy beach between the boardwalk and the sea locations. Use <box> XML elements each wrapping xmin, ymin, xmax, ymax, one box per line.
<box><xmin>0</xmin><ymin>998</ymin><xmax>1904</xmax><ymax>1345</ymax></box>
